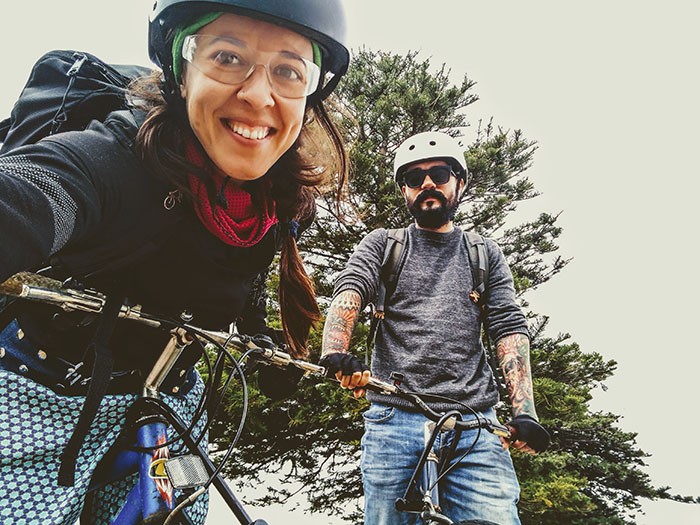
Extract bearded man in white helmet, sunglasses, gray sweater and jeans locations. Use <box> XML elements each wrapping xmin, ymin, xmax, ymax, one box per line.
<box><xmin>321</xmin><ymin>132</ymin><xmax>549</xmax><ymax>525</ymax></box>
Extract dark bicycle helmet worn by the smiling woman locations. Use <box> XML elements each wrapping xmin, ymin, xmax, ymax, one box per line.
<box><xmin>148</xmin><ymin>0</ymin><xmax>350</xmax><ymax>101</ymax></box>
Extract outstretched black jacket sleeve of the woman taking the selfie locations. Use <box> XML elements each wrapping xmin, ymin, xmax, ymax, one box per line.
<box><xmin>0</xmin><ymin>112</ymin><xmax>154</xmax><ymax>279</ymax></box>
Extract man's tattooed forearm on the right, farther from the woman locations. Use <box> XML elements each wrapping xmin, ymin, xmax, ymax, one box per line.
<box><xmin>496</xmin><ymin>334</ymin><xmax>537</xmax><ymax>418</ymax></box>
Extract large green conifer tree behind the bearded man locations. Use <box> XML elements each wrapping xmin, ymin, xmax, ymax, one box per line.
<box><xmin>206</xmin><ymin>49</ymin><xmax>684</xmax><ymax>524</ymax></box>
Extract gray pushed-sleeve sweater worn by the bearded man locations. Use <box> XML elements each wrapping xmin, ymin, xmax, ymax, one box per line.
<box><xmin>334</xmin><ymin>225</ymin><xmax>528</xmax><ymax>410</ymax></box>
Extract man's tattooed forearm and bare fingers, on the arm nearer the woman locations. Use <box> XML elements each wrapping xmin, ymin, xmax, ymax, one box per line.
<box><xmin>321</xmin><ymin>290</ymin><xmax>370</xmax><ymax>397</ymax></box>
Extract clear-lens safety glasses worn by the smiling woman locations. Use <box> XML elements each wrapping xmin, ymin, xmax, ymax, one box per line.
<box><xmin>182</xmin><ymin>34</ymin><xmax>321</xmax><ymax>98</ymax></box>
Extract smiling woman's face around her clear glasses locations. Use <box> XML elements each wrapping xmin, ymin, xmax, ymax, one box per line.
<box><xmin>181</xmin><ymin>14</ymin><xmax>313</xmax><ymax>183</ymax></box>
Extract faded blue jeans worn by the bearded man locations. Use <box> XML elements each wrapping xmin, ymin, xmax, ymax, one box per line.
<box><xmin>361</xmin><ymin>403</ymin><xmax>520</xmax><ymax>525</ymax></box>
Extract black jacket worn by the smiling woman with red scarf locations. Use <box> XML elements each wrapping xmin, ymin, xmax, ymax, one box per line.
<box><xmin>0</xmin><ymin>112</ymin><xmax>281</xmax><ymax>370</ymax></box>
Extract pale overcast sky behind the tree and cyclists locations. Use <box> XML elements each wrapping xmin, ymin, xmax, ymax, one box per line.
<box><xmin>0</xmin><ymin>0</ymin><xmax>700</xmax><ymax>525</ymax></box>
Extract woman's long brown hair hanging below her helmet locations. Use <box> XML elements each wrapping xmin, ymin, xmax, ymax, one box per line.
<box><xmin>130</xmin><ymin>72</ymin><xmax>348</xmax><ymax>357</ymax></box>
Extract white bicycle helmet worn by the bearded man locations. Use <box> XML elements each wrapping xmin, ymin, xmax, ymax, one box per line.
<box><xmin>394</xmin><ymin>131</ymin><xmax>469</xmax><ymax>185</ymax></box>
